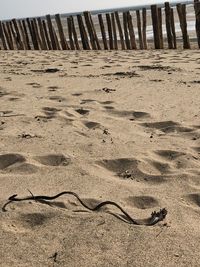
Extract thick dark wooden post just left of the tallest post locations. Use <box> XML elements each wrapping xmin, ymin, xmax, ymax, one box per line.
<box><xmin>151</xmin><ymin>5</ymin><xmax>161</xmax><ymax>49</ymax></box>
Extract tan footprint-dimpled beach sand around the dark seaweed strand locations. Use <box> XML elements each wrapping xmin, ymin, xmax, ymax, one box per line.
<box><xmin>0</xmin><ymin>50</ymin><xmax>200</xmax><ymax>267</ymax></box>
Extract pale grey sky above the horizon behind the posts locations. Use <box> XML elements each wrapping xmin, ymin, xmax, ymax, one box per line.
<box><xmin>0</xmin><ymin>0</ymin><xmax>187</xmax><ymax>20</ymax></box>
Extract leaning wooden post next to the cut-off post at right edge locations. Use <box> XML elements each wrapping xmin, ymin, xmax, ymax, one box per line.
<box><xmin>176</xmin><ymin>4</ymin><xmax>190</xmax><ymax>49</ymax></box>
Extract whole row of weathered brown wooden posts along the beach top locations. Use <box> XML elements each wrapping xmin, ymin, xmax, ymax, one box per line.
<box><xmin>0</xmin><ymin>0</ymin><xmax>200</xmax><ymax>50</ymax></box>
